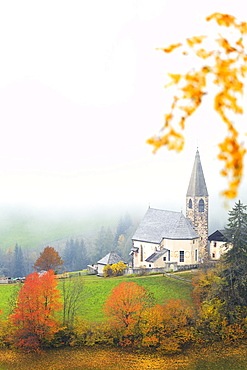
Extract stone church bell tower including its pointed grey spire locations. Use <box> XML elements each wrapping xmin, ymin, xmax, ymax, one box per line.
<box><xmin>186</xmin><ymin>150</ymin><xmax>208</xmax><ymax>260</ymax></box>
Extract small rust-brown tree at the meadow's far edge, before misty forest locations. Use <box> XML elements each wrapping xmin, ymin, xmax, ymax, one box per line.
<box><xmin>34</xmin><ymin>247</ymin><xmax>64</xmax><ymax>271</ymax></box>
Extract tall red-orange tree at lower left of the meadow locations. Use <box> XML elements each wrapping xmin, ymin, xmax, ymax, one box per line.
<box><xmin>10</xmin><ymin>270</ymin><xmax>62</xmax><ymax>351</ymax></box>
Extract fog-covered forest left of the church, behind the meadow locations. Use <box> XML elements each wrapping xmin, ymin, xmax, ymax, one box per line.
<box><xmin>0</xmin><ymin>213</ymin><xmax>136</xmax><ymax>278</ymax></box>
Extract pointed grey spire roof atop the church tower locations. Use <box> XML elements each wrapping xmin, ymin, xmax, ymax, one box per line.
<box><xmin>186</xmin><ymin>149</ymin><xmax>208</xmax><ymax>197</ymax></box>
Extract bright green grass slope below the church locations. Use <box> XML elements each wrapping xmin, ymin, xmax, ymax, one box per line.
<box><xmin>0</xmin><ymin>275</ymin><xmax>192</xmax><ymax>321</ymax></box>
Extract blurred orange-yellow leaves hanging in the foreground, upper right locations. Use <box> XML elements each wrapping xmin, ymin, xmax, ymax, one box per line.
<box><xmin>147</xmin><ymin>13</ymin><xmax>247</xmax><ymax>198</ymax></box>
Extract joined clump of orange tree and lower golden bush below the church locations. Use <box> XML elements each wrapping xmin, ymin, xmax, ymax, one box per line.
<box><xmin>105</xmin><ymin>282</ymin><xmax>193</xmax><ymax>353</ymax></box>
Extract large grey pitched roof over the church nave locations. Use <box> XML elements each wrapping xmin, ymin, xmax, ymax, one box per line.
<box><xmin>132</xmin><ymin>208</ymin><xmax>198</xmax><ymax>244</ymax></box>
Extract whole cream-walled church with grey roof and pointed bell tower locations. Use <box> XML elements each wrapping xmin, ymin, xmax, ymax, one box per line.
<box><xmin>130</xmin><ymin>150</ymin><xmax>208</xmax><ymax>268</ymax></box>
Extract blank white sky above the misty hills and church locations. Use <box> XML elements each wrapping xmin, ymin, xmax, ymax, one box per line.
<box><xmin>0</xmin><ymin>0</ymin><xmax>247</xmax><ymax>227</ymax></box>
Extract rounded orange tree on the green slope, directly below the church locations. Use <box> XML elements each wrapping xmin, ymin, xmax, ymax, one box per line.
<box><xmin>104</xmin><ymin>281</ymin><xmax>152</xmax><ymax>345</ymax></box>
